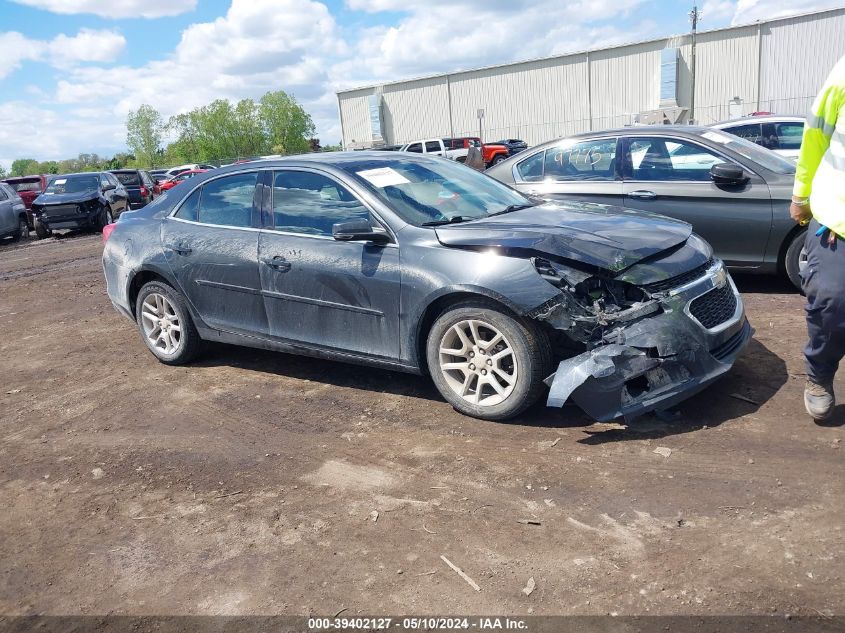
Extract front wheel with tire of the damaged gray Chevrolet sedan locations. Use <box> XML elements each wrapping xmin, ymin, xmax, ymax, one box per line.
<box><xmin>426</xmin><ymin>302</ymin><xmax>551</xmax><ymax>420</ymax></box>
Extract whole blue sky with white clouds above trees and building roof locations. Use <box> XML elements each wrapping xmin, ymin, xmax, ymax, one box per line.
<box><xmin>0</xmin><ymin>0</ymin><xmax>842</xmax><ymax>167</ymax></box>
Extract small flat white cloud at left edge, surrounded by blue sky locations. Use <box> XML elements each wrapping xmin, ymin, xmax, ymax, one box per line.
<box><xmin>0</xmin><ymin>29</ymin><xmax>126</xmax><ymax>79</ymax></box>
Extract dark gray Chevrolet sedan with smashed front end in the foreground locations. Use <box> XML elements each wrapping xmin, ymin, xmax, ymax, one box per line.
<box><xmin>103</xmin><ymin>152</ymin><xmax>752</xmax><ymax>420</ymax></box>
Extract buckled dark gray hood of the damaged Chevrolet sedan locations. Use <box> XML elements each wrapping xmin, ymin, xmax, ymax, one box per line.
<box><xmin>436</xmin><ymin>202</ymin><xmax>692</xmax><ymax>272</ymax></box>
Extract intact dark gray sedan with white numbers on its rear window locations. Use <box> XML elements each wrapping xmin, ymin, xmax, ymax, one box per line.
<box><xmin>485</xmin><ymin>125</ymin><xmax>806</xmax><ymax>287</ymax></box>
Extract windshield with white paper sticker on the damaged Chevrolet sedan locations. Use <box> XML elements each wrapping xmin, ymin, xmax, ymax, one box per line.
<box><xmin>342</xmin><ymin>159</ymin><xmax>532</xmax><ymax>226</ymax></box>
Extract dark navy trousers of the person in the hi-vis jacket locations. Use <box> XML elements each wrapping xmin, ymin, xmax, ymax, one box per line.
<box><xmin>801</xmin><ymin>220</ymin><xmax>845</xmax><ymax>384</ymax></box>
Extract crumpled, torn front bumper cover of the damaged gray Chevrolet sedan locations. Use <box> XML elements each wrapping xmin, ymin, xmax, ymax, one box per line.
<box><xmin>545</xmin><ymin>262</ymin><xmax>754</xmax><ymax>421</ymax></box>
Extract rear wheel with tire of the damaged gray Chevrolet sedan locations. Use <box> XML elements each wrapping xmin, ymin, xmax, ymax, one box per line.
<box><xmin>135</xmin><ymin>281</ymin><xmax>202</xmax><ymax>365</ymax></box>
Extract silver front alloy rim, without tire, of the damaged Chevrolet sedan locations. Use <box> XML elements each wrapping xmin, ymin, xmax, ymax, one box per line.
<box><xmin>439</xmin><ymin>319</ymin><xmax>519</xmax><ymax>406</ymax></box>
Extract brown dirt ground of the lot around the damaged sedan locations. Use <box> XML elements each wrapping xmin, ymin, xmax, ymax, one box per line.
<box><xmin>0</xmin><ymin>236</ymin><xmax>845</xmax><ymax>616</ymax></box>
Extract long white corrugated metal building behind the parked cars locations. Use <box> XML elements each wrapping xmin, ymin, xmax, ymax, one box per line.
<box><xmin>337</xmin><ymin>7</ymin><xmax>845</xmax><ymax>149</ymax></box>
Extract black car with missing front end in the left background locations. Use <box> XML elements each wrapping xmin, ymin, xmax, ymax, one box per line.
<box><xmin>32</xmin><ymin>171</ymin><xmax>129</xmax><ymax>239</ymax></box>
